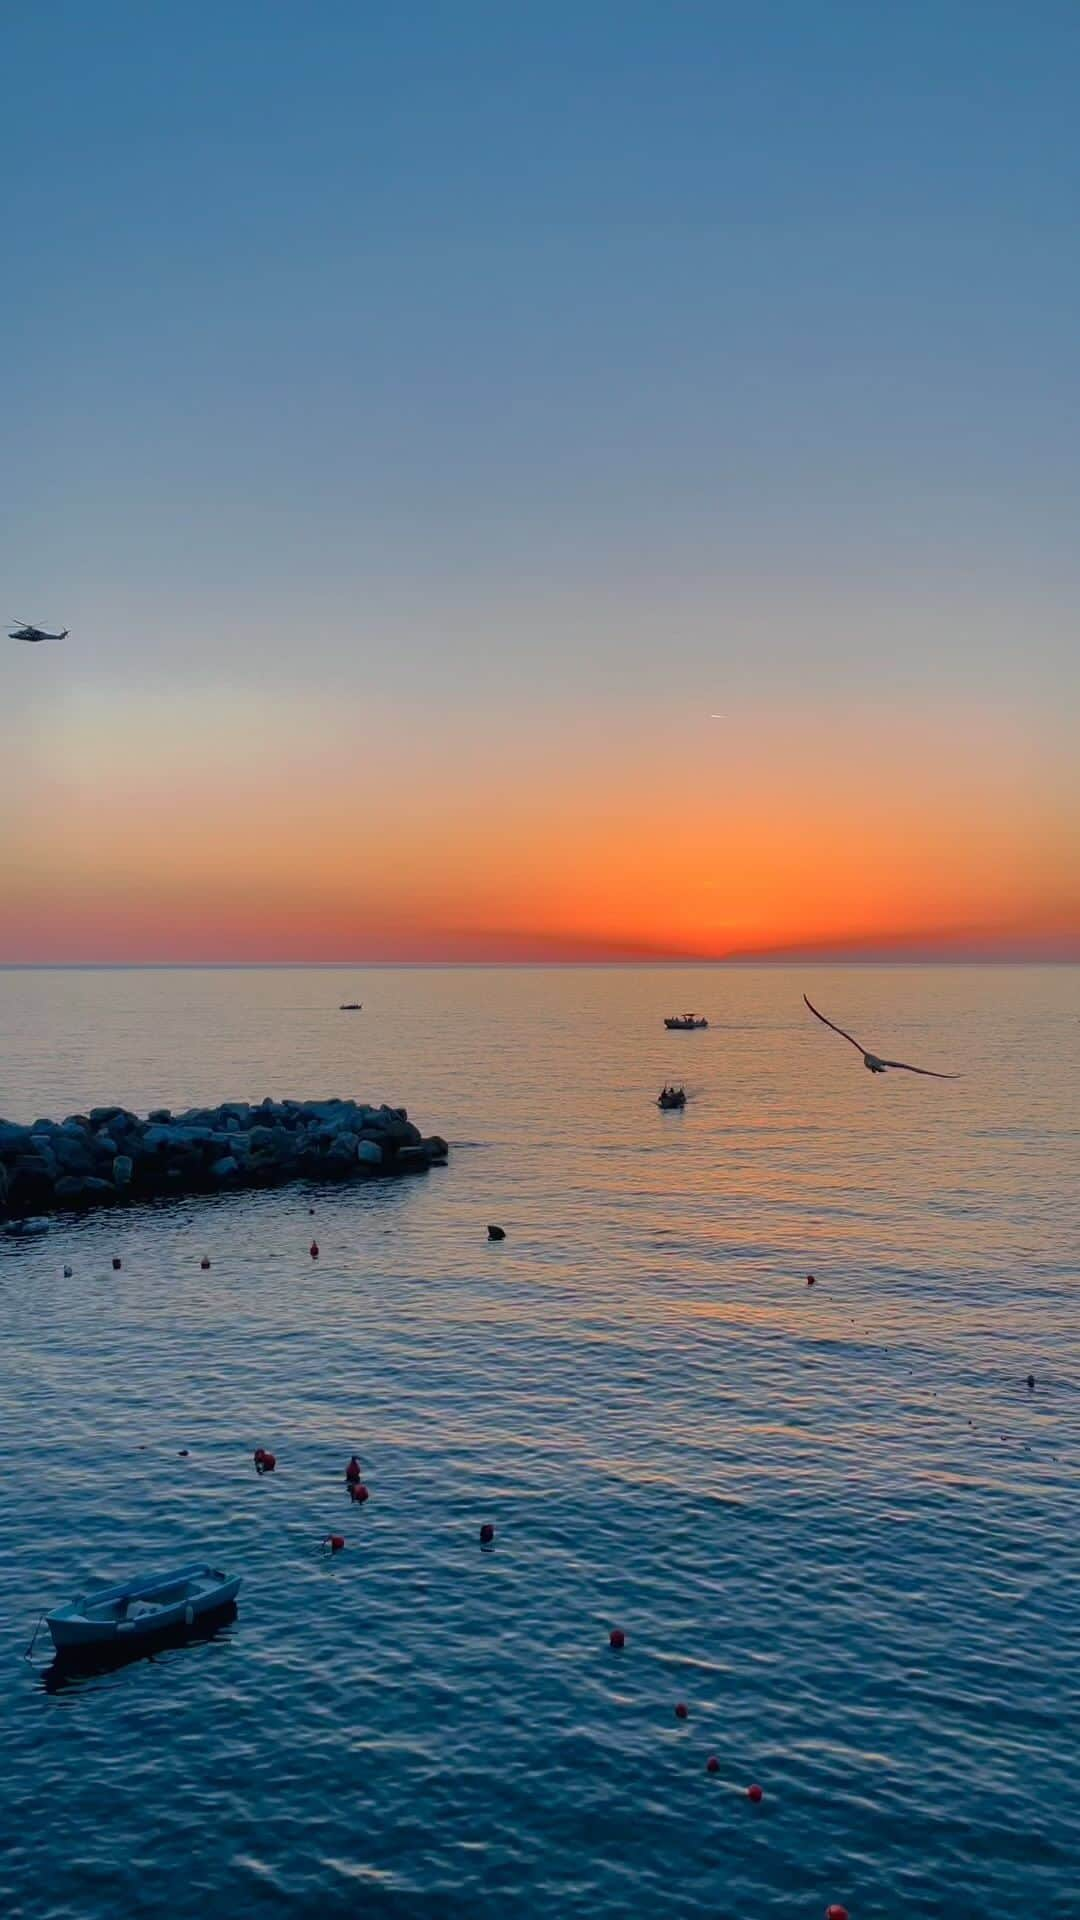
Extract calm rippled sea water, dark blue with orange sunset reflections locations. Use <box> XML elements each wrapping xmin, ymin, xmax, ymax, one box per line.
<box><xmin>0</xmin><ymin>968</ymin><xmax>1080</xmax><ymax>1920</ymax></box>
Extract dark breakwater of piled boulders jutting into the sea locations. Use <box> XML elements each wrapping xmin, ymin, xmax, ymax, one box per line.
<box><xmin>0</xmin><ymin>1100</ymin><xmax>448</xmax><ymax>1219</ymax></box>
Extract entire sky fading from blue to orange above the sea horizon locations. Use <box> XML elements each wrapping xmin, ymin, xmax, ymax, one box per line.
<box><xmin>0</xmin><ymin>0</ymin><xmax>1080</xmax><ymax>964</ymax></box>
